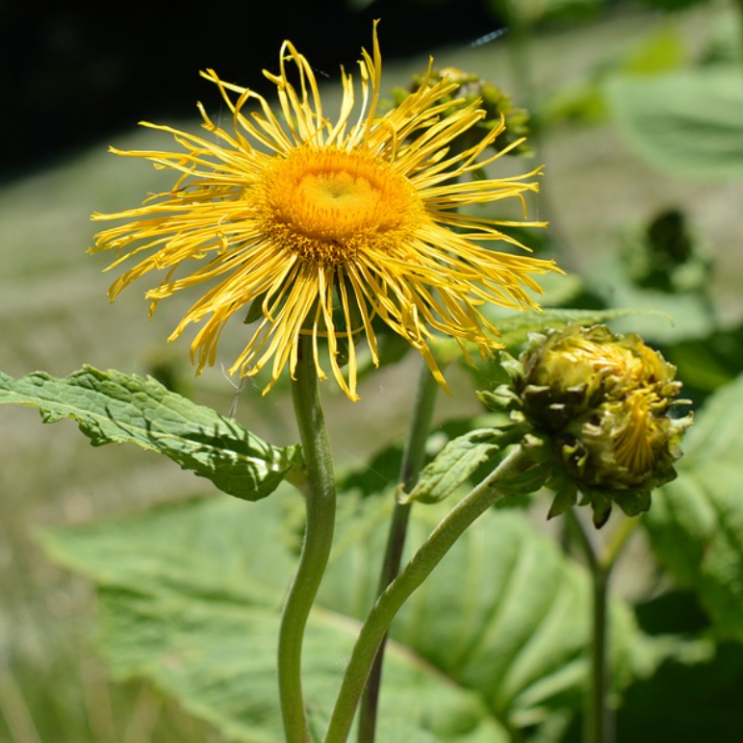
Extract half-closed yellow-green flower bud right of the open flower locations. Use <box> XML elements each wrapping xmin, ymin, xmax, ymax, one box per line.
<box><xmin>483</xmin><ymin>325</ymin><xmax>692</xmax><ymax>526</ymax></box>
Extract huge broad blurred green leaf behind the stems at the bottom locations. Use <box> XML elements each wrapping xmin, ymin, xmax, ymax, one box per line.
<box><xmin>45</xmin><ymin>488</ymin><xmax>632</xmax><ymax>743</ymax></box>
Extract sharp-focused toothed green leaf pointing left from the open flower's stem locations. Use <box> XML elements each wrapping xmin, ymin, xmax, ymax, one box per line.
<box><xmin>0</xmin><ymin>366</ymin><xmax>301</xmax><ymax>500</ymax></box>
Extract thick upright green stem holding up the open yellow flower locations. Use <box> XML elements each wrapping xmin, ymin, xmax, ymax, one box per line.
<box><xmin>278</xmin><ymin>337</ymin><xmax>335</xmax><ymax>743</ymax></box>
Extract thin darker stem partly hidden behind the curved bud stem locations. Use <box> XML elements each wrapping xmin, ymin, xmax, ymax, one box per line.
<box><xmin>357</xmin><ymin>364</ymin><xmax>439</xmax><ymax>743</ymax></box>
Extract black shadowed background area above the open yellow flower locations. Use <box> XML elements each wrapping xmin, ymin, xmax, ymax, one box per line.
<box><xmin>0</xmin><ymin>0</ymin><xmax>506</xmax><ymax>181</ymax></box>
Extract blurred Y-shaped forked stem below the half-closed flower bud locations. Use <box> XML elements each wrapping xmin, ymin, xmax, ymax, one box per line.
<box><xmin>568</xmin><ymin>510</ymin><xmax>638</xmax><ymax>743</ymax></box>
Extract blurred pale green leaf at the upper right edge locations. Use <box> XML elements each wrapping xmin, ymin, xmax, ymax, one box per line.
<box><xmin>607</xmin><ymin>65</ymin><xmax>743</xmax><ymax>178</ymax></box>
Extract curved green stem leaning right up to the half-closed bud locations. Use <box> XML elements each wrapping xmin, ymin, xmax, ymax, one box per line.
<box><xmin>325</xmin><ymin>447</ymin><xmax>533</xmax><ymax>743</ymax></box>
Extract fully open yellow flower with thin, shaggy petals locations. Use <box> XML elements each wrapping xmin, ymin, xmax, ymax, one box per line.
<box><xmin>91</xmin><ymin>28</ymin><xmax>557</xmax><ymax>399</ymax></box>
